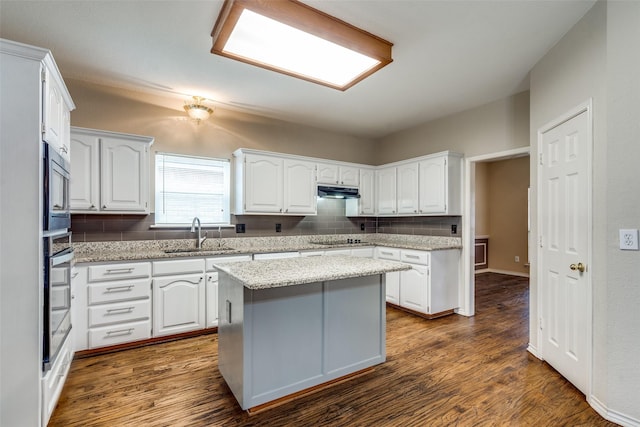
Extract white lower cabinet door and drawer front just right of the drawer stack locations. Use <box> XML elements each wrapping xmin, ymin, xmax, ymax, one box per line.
<box><xmin>152</xmin><ymin>259</ymin><xmax>206</xmax><ymax>337</ymax></box>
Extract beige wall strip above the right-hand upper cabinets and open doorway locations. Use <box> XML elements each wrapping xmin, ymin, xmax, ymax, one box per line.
<box><xmin>376</xmin><ymin>92</ymin><xmax>529</xmax><ymax>164</ymax></box>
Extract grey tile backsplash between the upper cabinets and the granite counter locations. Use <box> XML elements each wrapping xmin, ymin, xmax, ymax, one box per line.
<box><xmin>71</xmin><ymin>199</ymin><xmax>462</xmax><ymax>242</ymax></box>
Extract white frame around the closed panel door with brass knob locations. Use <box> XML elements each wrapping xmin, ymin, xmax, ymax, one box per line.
<box><xmin>530</xmin><ymin>98</ymin><xmax>594</xmax><ymax>400</ymax></box>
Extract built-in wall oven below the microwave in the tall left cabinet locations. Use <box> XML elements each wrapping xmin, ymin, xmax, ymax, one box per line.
<box><xmin>42</xmin><ymin>234</ymin><xmax>73</xmax><ymax>371</ymax></box>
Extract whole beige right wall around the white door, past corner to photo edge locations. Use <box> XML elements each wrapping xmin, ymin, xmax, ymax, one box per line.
<box><xmin>530</xmin><ymin>0</ymin><xmax>640</xmax><ymax>418</ymax></box>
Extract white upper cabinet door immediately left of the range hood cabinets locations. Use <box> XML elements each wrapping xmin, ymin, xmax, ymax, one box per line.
<box><xmin>284</xmin><ymin>159</ymin><xmax>317</xmax><ymax>214</ymax></box>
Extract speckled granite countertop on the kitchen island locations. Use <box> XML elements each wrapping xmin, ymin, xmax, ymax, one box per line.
<box><xmin>214</xmin><ymin>255</ymin><xmax>411</xmax><ymax>290</ymax></box>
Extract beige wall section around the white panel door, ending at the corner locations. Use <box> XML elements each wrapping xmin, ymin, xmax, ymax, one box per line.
<box><xmin>529</xmin><ymin>1</ymin><xmax>609</xmax><ymax>410</ymax></box>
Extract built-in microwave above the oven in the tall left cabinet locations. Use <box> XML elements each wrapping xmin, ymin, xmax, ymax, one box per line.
<box><xmin>42</xmin><ymin>142</ymin><xmax>71</xmax><ymax>232</ymax></box>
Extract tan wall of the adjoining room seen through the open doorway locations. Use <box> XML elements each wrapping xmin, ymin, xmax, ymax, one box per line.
<box><xmin>476</xmin><ymin>156</ymin><xmax>529</xmax><ymax>274</ymax></box>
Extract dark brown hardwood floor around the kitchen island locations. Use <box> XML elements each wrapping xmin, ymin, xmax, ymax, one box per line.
<box><xmin>49</xmin><ymin>273</ymin><xmax>615</xmax><ymax>427</ymax></box>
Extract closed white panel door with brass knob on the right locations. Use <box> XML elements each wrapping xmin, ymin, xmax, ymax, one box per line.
<box><xmin>539</xmin><ymin>111</ymin><xmax>591</xmax><ymax>393</ymax></box>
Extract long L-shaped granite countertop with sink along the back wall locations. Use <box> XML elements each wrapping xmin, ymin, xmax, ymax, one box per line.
<box><xmin>73</xmin><ymin>234</ymin><xmax>462</xmax><ymax>263</ymax></box>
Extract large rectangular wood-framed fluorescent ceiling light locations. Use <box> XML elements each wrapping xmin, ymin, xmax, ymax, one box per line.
<box><xmin>211</xmin><ymin>0</ymin><xmax>393</xmax><ymax>90</ymax></box>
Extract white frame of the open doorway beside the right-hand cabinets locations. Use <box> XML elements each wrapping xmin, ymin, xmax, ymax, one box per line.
<box><xmin>456</xmin><ymin>146</ymin><xmax>531</xmax><ymax>316</ymax></box>
